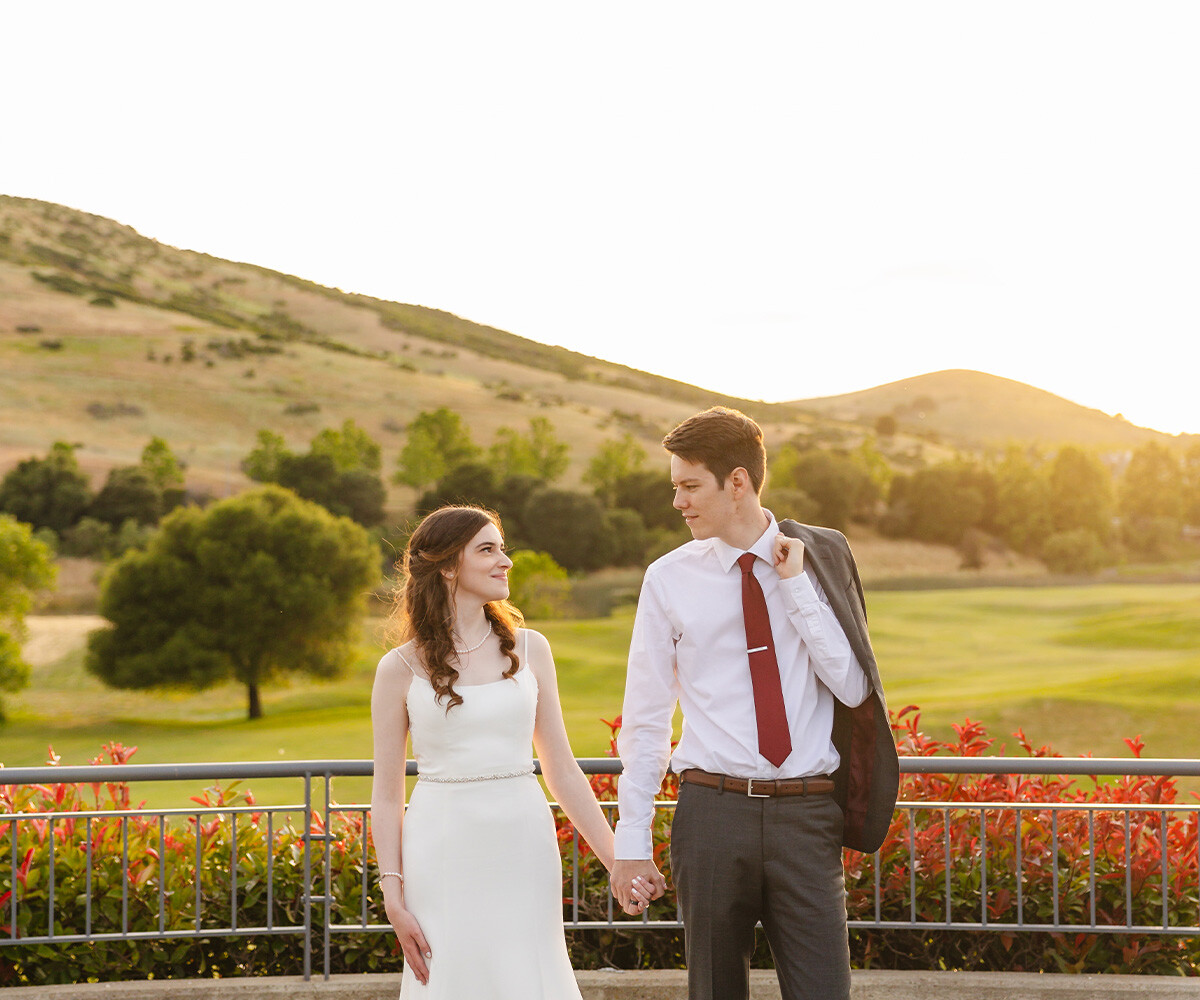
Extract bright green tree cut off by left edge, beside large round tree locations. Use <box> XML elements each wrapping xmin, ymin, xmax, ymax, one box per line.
<box><xmin>0</xmin><ymin>514</ymin><xmax>55</xmax><ymax>723</ymax></box>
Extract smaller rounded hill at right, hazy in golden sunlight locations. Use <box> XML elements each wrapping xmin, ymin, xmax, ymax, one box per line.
<box><xmin>794</xmin><ymin>369</ymin><xmax>1172</xmax><ymax>449</ymax></box>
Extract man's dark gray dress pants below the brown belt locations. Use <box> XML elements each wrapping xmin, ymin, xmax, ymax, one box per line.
<box><xmin>671</xmin><ymin>783</ymin><xmax>850</xmax><ymax>1000</ymax></box>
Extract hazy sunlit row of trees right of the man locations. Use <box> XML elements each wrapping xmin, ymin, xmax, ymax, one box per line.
<box><xmin>769</xmin><ymin>442</ymin><xmax>1200</xmax><ymax>573</ymax></box>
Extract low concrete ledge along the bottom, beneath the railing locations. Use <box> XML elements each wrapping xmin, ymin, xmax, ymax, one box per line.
<box><xmin>2</xmin><ymin>969</ymin><xmax>1200</xmax><ymax>1000</ymax></box>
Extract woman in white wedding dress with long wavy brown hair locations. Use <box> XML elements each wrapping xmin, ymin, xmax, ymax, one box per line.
<box><xmin>371</xmin><ymin>507</ymin><xmax>650</xmax><ymax>1000</ymax></box>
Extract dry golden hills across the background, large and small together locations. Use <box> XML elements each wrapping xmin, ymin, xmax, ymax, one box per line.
<box><xmin>0</xmin><ymin>196</ymin><xmax>1180</xmax><ymax>511</ymax></box>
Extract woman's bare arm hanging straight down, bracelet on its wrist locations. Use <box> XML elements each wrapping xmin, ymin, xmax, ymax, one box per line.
<box><xmin>371</xmin><ymin>652</ymin><xmax>431</xmax><ymax>984</ymax></box>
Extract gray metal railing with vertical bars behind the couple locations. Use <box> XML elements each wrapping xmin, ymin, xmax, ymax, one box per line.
<box><xmin>0</xmin><ymin>756</ymin><xmax>1200</xmax><ymax>978</ymax></box>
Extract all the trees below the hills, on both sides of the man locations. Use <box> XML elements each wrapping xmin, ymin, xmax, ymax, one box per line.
<box><xmin>0</xmin><ymin>407</ymin><xmax>1200</xmax><ymax>718</ymax></box>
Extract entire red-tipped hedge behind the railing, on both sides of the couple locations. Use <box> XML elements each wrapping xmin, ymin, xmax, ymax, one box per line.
<box><xmin>0</xmin><ymin>708</ymin><xmax>1200</xmax><ymax>987</ymax></box>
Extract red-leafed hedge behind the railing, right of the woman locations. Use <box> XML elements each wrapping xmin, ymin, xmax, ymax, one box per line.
<box><xmin>559</xmin><ymin>706</ymin><xmax>1200</xmax><ymax>976</ymax></box>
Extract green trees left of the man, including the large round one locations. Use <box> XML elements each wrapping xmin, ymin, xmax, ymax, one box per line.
<box><xmin>0</xmin><ymin>408</ymin><xmax>680</xmax><ymax>718</ymax></box>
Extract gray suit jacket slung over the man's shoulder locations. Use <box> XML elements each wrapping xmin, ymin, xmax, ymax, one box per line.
<box><xmin>779</xmin><ymin>520</ymin><xmax>900</xmax><ymax>854</ymax></box>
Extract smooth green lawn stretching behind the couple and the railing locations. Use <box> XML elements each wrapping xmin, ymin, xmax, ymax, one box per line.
<box><xmin>0</xmin><ymin>583</ymin><xmax>1200</xmax><ymax>803</ymax></box>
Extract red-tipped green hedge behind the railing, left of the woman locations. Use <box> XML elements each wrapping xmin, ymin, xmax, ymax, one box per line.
<box><xmin>0</xmin><ymin>743</ymin><xmax>401</xmax><ymax>987</ymax></box>
